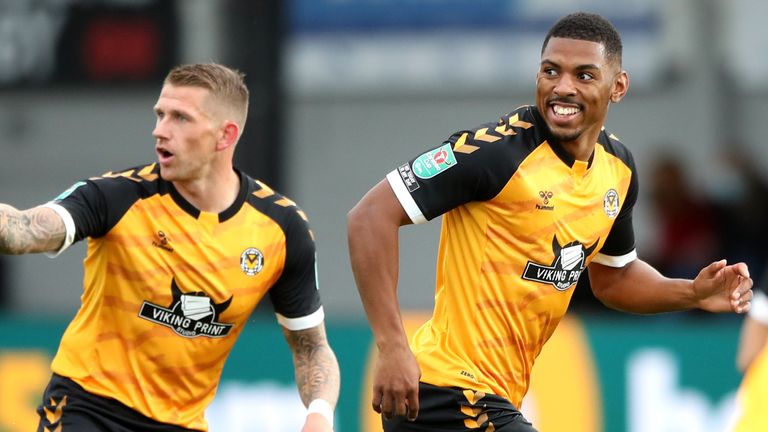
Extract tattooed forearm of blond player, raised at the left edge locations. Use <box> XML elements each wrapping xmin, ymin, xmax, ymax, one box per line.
<box><xmin>0</xmin><ymin>204</ymin><xmax>66</xmax><ymax>255</ymax></box>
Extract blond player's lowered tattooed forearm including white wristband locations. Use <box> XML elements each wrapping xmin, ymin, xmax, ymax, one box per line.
<box><xmin>283</xmin><ymin>323</ymin><xmax>340</xmax><ymax>432</ymax></box>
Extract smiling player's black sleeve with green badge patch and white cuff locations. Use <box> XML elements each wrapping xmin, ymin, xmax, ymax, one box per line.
<box><xmin>387</xmin><ymin>125</ymin><xmax>528</xmax><ymax>223</ymax></box>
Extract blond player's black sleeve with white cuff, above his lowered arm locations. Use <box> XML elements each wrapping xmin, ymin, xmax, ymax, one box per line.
<box><xmin>269</xmin><ymin>212</ymin><xmax>325</xmax><ymax>330</ymax></box>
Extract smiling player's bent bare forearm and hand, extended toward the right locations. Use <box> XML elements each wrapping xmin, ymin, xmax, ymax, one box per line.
<box><xmin>589</xmin><ymin>259</ymin><xmax>752</xmax><ymax>313</ymax></box>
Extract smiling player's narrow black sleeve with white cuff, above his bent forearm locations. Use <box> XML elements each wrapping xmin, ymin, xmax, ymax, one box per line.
<box><xmin>593</xmin><ymin>151</ymin><xmax>639</xmax><ymax>267</ymax></box>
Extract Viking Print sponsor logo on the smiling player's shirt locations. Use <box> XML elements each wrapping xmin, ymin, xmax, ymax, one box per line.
<box><xmin>523</xmin><ymin>235</ymin><xmax>599</xmax><ymax>291</ymax></box>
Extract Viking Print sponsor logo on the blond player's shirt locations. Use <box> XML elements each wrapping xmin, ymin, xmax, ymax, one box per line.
<box><xmin>139</xmin><ymin>278</ymin><xmax>234</xmax><ymax>338</ymax></box>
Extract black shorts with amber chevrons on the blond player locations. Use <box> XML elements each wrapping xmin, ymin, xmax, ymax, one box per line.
<box><xmin>37</xmin><ymin>374</ymin><xmax>200</xmax><ymax>432</ymax></box>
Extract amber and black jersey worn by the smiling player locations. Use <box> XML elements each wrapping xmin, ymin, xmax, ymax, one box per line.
<box><xmin>387</xmin><ymin>106</ymin><xmax>637</xmax><ymax>407</ymax></box>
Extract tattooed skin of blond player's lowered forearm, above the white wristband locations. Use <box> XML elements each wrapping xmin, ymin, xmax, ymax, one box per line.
<box><xmin>283</xmin><ymin>324</ymin><xmax>339</xmax><ymax>406</ymax></box>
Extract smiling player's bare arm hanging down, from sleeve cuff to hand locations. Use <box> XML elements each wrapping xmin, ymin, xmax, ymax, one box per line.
<box><xmin>347</xmin><ymin>180</ymin><xmax>421</xmax><ymax>420</ymax></box>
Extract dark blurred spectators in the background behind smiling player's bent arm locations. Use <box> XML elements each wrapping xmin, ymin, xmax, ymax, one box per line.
<box><xmin>572</xmin><ymin>146</ymin><xmax>768</xmax><ymax>310</ymax></box>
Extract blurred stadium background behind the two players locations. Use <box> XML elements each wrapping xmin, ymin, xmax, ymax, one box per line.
<box><xmin>0</xmin><ymin>0</ymin><xmax>768</xmax><ymax>432</ymax></box>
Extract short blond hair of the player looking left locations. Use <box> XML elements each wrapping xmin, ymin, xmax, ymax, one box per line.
<box><xmin>163</xmin><ymin>63</ymin><xmax>248</xmax><ymax>128</ymax></box>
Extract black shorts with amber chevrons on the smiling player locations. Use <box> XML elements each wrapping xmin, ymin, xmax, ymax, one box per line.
<box><xmin>382</xmin><ymin>383</ymin><xmax>536</xmax><ymax>432</ymax></box>
